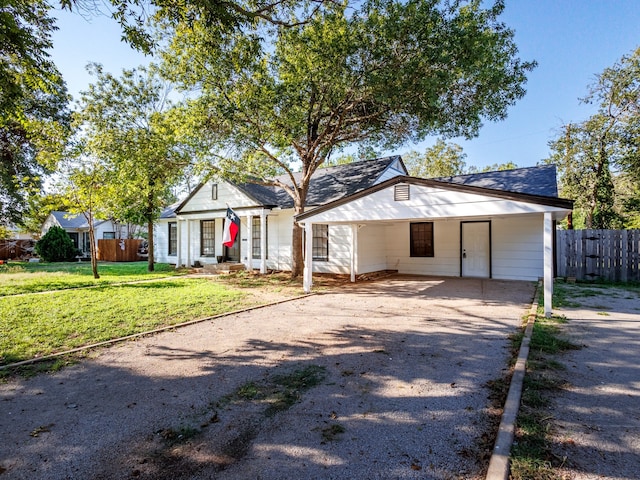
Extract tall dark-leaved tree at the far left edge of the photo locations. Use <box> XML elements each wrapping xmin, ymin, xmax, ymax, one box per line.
<box><xmin>0</xmin><ymin>0</ymin><xmax>69</xmax><ymax>223</ymax></box>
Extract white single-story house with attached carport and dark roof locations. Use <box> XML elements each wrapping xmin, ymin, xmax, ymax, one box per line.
<box><xmin>155</xmin><ymin>156</ymin><xmax>572</xmax><ymax>316</ymax></box>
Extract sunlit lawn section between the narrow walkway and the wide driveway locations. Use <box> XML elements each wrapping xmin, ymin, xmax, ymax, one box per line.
<box><xmin>0</xmin><ymin>278</ymin><xmax>248</xmax><ymax>364</ymax></box>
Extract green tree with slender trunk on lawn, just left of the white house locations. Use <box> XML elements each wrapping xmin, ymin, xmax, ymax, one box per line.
<box><xmin>76</xmin><ymin>64</ymin><xmax>191</xmax><ymax>271</ymax></box>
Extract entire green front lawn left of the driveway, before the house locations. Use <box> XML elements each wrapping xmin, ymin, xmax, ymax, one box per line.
<box><xmin>0</xmin><ymin>262</ymin><xmax>302</xmax><ymax>372</ymax></box>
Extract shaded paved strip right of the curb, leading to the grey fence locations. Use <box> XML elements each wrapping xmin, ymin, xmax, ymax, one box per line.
<box><xmin>553</xmin><ymin>285</ymin><xmax>640</xmax><ymax>480</ymax></box>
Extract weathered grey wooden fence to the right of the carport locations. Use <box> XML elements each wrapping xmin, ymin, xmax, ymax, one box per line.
<box><xmin>556</xmin><ymin>230</ymin><xmax>640</xmax><ymax>282</ymax></box>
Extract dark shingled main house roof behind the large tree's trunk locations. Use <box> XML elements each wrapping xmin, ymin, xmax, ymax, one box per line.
<box><xmin>238</xmin><ymin>155</ymin><xmax>401</xmax><ymax>208</ymax></box>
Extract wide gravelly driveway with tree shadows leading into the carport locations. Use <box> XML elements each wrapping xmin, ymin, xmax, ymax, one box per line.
<box><xmin>0</xmin><ymin>277</ymin><xmax>534</xmax><ymax>480</ymax></box>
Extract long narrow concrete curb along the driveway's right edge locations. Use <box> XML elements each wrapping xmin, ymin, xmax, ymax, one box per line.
<box><xmin>486</xmin><ymin>283</ymin><xmax>541</xmax><ymax>480</ymax></box>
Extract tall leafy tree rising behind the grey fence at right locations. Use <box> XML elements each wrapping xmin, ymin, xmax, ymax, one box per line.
<box><xmin>547</xmin><ymin>48</ymin><xmax>640</xmax><ymax>228</ymax></box>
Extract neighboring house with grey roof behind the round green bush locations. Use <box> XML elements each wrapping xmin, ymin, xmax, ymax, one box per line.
<box><xmin>42</xmin><ymin>211</ymin><xmax>133</xmax><ymax>256</ymax></box>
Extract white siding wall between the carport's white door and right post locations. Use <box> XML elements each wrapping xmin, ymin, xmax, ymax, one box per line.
<box><xmin>491</xmin><ymin>214</ymin><xmax>544</xmax><ymax>281</ymax></box>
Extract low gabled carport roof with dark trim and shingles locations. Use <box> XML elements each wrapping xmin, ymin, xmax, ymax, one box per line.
<box><xmin>295</xmin><ymin>165</ymin><xmax>573</xmax><ymax>221</ymax></box>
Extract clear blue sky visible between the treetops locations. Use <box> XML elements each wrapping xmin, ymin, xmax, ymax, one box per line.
<box><xmin>52</xmin><ymin>0</ymin><xmax>640</xmax><ymax>171</ymax></box>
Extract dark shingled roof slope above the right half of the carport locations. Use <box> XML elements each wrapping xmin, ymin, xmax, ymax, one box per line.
<box><xmin>431</xmin><ymin>165</ymin><xmax>558</xmax><ymax>197</ymax></box>
